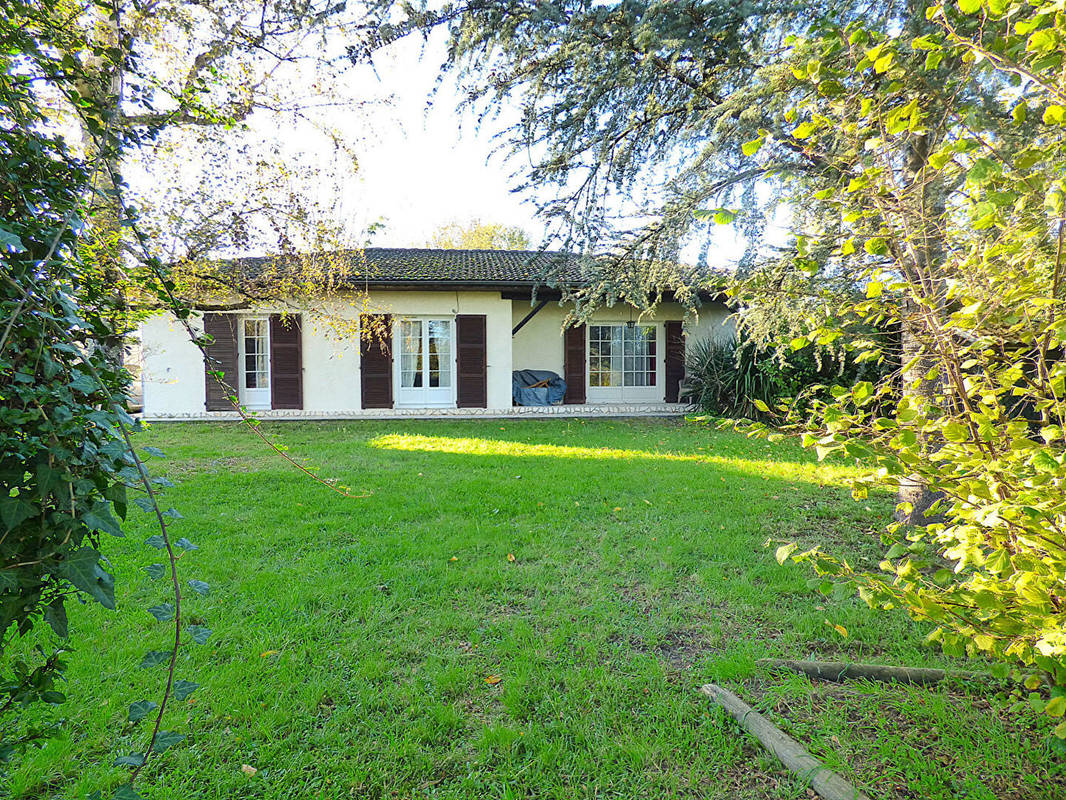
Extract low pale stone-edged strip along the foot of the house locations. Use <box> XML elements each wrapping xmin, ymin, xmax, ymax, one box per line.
<box><xmin>144</xmin><ymin>403</ymin><xmax>692</xmax><ymax>422</ymax></box>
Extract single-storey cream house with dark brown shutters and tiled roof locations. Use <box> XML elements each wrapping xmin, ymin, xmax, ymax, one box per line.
<box><xmin>140</xmin><ymin>247</ymin><xmax>733</xmax><ymax>420</ymax></box>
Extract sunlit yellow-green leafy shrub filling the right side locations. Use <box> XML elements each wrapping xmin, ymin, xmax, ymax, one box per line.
<box><xmin>724</xmin><ymin>2</ymin><xmax>1066</xmax><ymax>738</ymax></box>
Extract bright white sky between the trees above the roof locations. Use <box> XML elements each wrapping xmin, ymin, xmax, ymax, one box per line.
<box><xmin>126</xmin><ymin>21</ymin><xmax>758</xmax><ymax>268</ymax></box>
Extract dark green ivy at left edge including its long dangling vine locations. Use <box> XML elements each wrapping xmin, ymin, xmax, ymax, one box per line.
<box><xmin>0</xmin><ymin>0</ymin><xmax>212</xmax><ymax>797</ymax></box>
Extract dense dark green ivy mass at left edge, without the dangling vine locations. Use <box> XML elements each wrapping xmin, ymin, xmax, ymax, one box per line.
<box><xmin>0</xmin><ymin>0</ymin><xmax>132</xmax><ymax>754</ymax></box>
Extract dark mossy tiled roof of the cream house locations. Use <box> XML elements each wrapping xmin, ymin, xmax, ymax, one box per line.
<box><xmin>233</xmin><ymin>247</ymin><xmax>584</xmax><ymax>286</ymax></box>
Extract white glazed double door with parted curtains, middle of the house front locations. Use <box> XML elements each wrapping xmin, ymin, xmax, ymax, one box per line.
<box><xmin>397</xmin><ymin>319</ymin><xmax>455</xmax><ymax>409</ymax></box>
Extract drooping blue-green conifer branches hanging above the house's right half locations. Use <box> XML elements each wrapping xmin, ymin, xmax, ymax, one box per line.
<box><xmin>351</xmin><ymin>0</ymin><xmax>922</xmax><ymax>305</ymax></box>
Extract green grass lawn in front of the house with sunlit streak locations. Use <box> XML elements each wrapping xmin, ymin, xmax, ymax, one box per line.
<box><xmin>0</xmin><ymin>419</ymin><xmax>1066</xmax><ymax>800</ymax></box>
